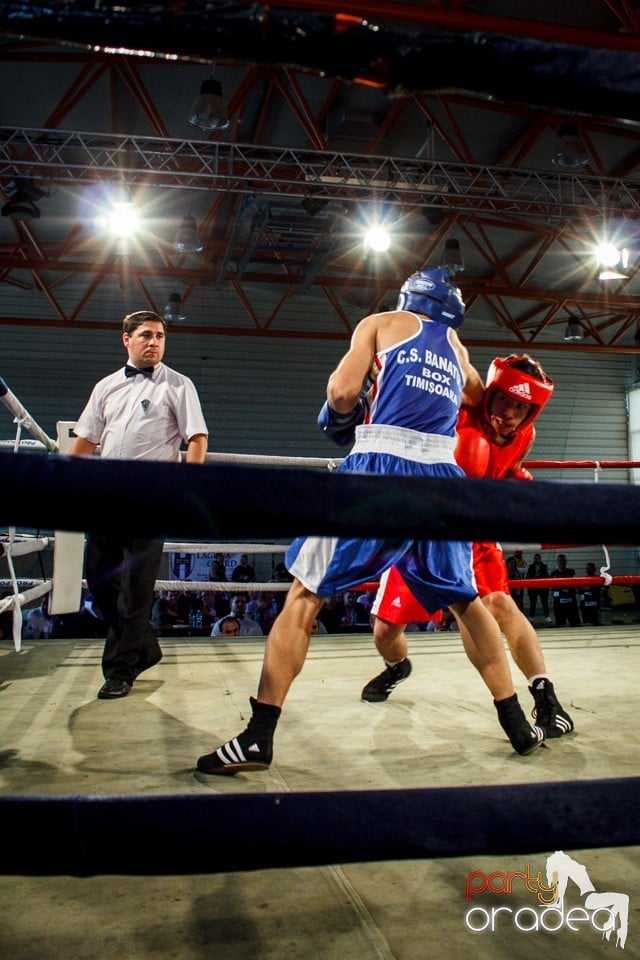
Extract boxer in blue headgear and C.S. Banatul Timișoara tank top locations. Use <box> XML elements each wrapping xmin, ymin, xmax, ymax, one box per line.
<box><xmin>197</xmin><ymin>267</ymin><xmax>543</xmax><ymax>775</ymax></box>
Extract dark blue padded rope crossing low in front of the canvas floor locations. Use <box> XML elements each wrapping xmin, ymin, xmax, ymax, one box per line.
<box><xmin>0</xmin><ymin>777</ymin><xmax>640</xmax><ymax>876</ymax></box>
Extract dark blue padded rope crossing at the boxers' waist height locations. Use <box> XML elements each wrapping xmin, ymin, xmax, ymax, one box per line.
<box><xmin>0</xmin><ymin>452</ymin><xmax>640</xmax><ymax>545</ymax></box>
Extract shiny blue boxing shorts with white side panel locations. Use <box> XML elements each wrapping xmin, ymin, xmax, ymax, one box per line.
<box><xmin>285</xmin><ymin>443</ymin><xmax>478</xmax><ymax>613</ymax></box>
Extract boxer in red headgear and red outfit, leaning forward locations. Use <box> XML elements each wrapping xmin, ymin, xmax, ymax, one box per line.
<box><xmin>362</xmin><ymin>355</ymin><xmax>573</xmax><ymax>738</ymax></box>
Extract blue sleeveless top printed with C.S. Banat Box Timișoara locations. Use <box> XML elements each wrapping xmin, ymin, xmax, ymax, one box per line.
<box><xmin>366</xmin><ymin>315</ymin><xmax>463</xmax><ymax>437</ymax></box>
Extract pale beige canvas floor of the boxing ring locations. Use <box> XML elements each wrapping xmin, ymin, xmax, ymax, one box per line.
<box><xmin>0</xmin><ymin>624</ymin><xmax>640</xmax><ymax>960</ymax></box>
